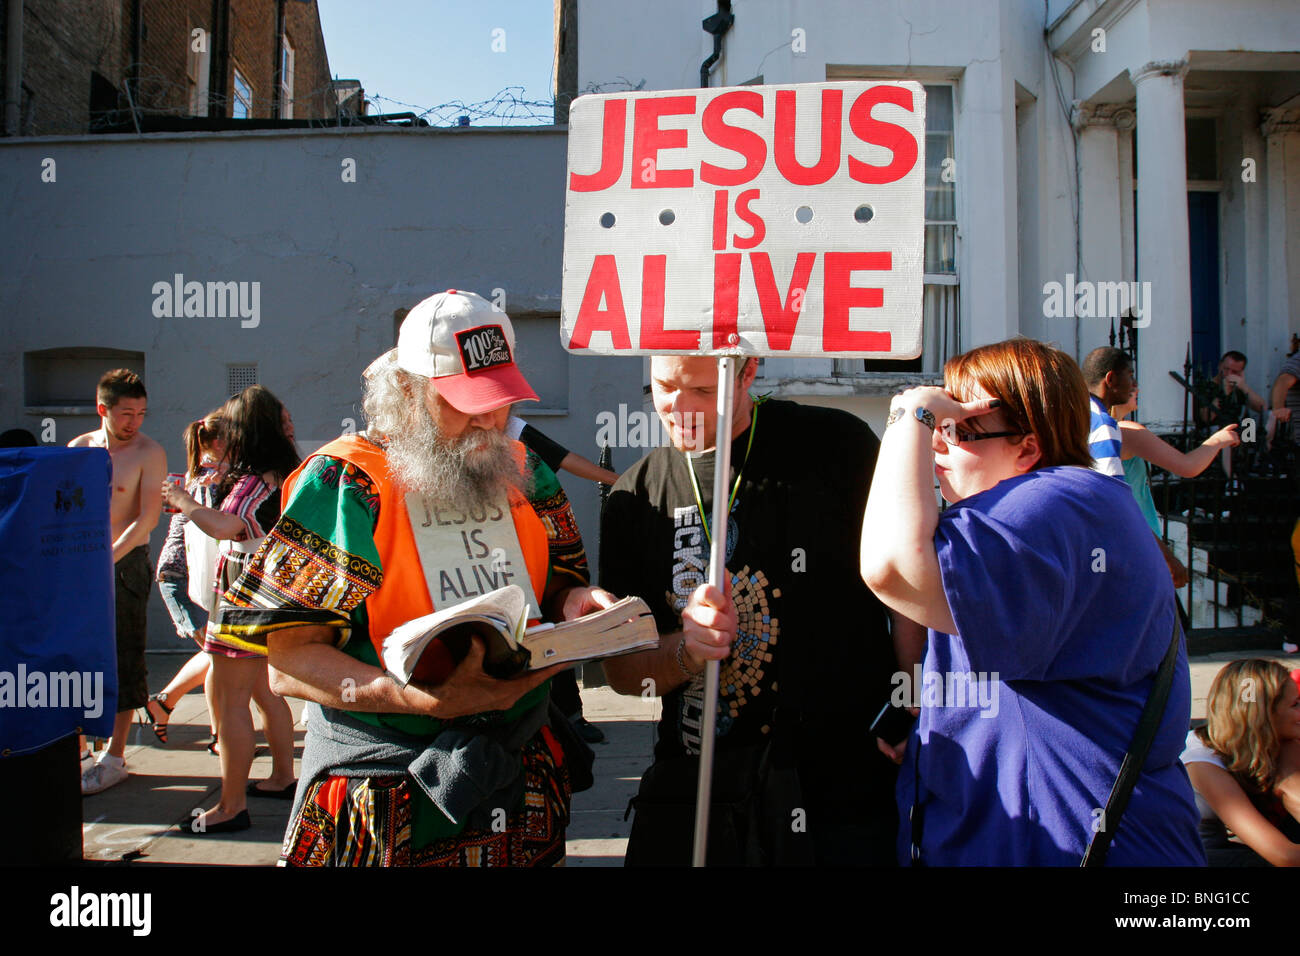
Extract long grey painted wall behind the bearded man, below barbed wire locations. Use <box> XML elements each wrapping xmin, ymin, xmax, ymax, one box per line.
<box><xmin>0</xmin><ymin>127</ymin><xmax>641</xmax><ymax>648</ymax></box>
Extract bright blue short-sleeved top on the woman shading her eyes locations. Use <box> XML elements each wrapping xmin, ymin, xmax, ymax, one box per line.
<box><xmin>898</xmin><ymin>467</ymin><xmax>1205</xmax><ymax>866</ymax></box>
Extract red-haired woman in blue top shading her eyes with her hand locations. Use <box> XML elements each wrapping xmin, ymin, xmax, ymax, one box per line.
<box><xmin>861</xmin><ymin>338</ymin><xmax>1205</xmax><ymax>866</ymax></box>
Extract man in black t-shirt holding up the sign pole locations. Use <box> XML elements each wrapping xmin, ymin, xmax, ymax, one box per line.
<box><xmin>601</xmin><ymin>356</ymin><xmax>924</xmax><ymax>865</ymax></box>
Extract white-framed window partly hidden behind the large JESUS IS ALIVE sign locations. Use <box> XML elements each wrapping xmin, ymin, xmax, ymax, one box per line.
<box><xmin>835</xmin><ymin>83</ymin><xmax>961</xmax><ymax>375</ymax></box>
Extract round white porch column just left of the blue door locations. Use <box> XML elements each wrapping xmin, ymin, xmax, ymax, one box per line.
<box><xmin>1131</xmin><ymin>60</ymin><xmax>1192</xmax><ymax>427</ymax></box>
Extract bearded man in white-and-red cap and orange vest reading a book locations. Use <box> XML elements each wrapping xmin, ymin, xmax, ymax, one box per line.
<box><xmin>216</xmin><ymin>290</ymin><xmax>612</xmax><ymax>866</ymax></box>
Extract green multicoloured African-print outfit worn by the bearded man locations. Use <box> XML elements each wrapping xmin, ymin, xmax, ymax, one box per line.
<box><xmin>215</xmin><ymin>437</ymin><xmax>588</xmax><ymax>865</ymax></box>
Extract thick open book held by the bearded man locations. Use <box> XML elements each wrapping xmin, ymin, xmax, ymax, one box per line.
<box><xmin>384</xmin><ymin>584</ymin><xmax>659</xmax><ymax>687</ymax></box>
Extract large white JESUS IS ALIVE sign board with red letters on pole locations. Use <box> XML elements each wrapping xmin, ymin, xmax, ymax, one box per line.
<box><xmin>562</xmin><ymin>81</ymin><xmax>926</xmax><ymax>359</ymax></box>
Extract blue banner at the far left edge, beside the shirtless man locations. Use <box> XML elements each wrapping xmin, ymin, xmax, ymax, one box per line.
<box><xmin>0</xmin><ymin>447</ymin><xmax>117</xmax><ymax>757</ymax></box>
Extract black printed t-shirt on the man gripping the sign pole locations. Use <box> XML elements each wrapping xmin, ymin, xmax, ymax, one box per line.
<box><xmin>601</xmin><ymin>401</ymin><xmax>896</xmax><ymax>812</ymax></box>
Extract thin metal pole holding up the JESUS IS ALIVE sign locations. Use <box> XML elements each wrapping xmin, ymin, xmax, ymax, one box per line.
<box><xmin>690</xmin><ymin>356</ymin><xmax>736</xmax><ymax>866</ymax></box>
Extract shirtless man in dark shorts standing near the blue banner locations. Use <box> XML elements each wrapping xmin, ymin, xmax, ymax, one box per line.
<box><xmin>68</xmin><ymin>368</ymin><xmax>166</xmax><ymax>796</ymax></box>
